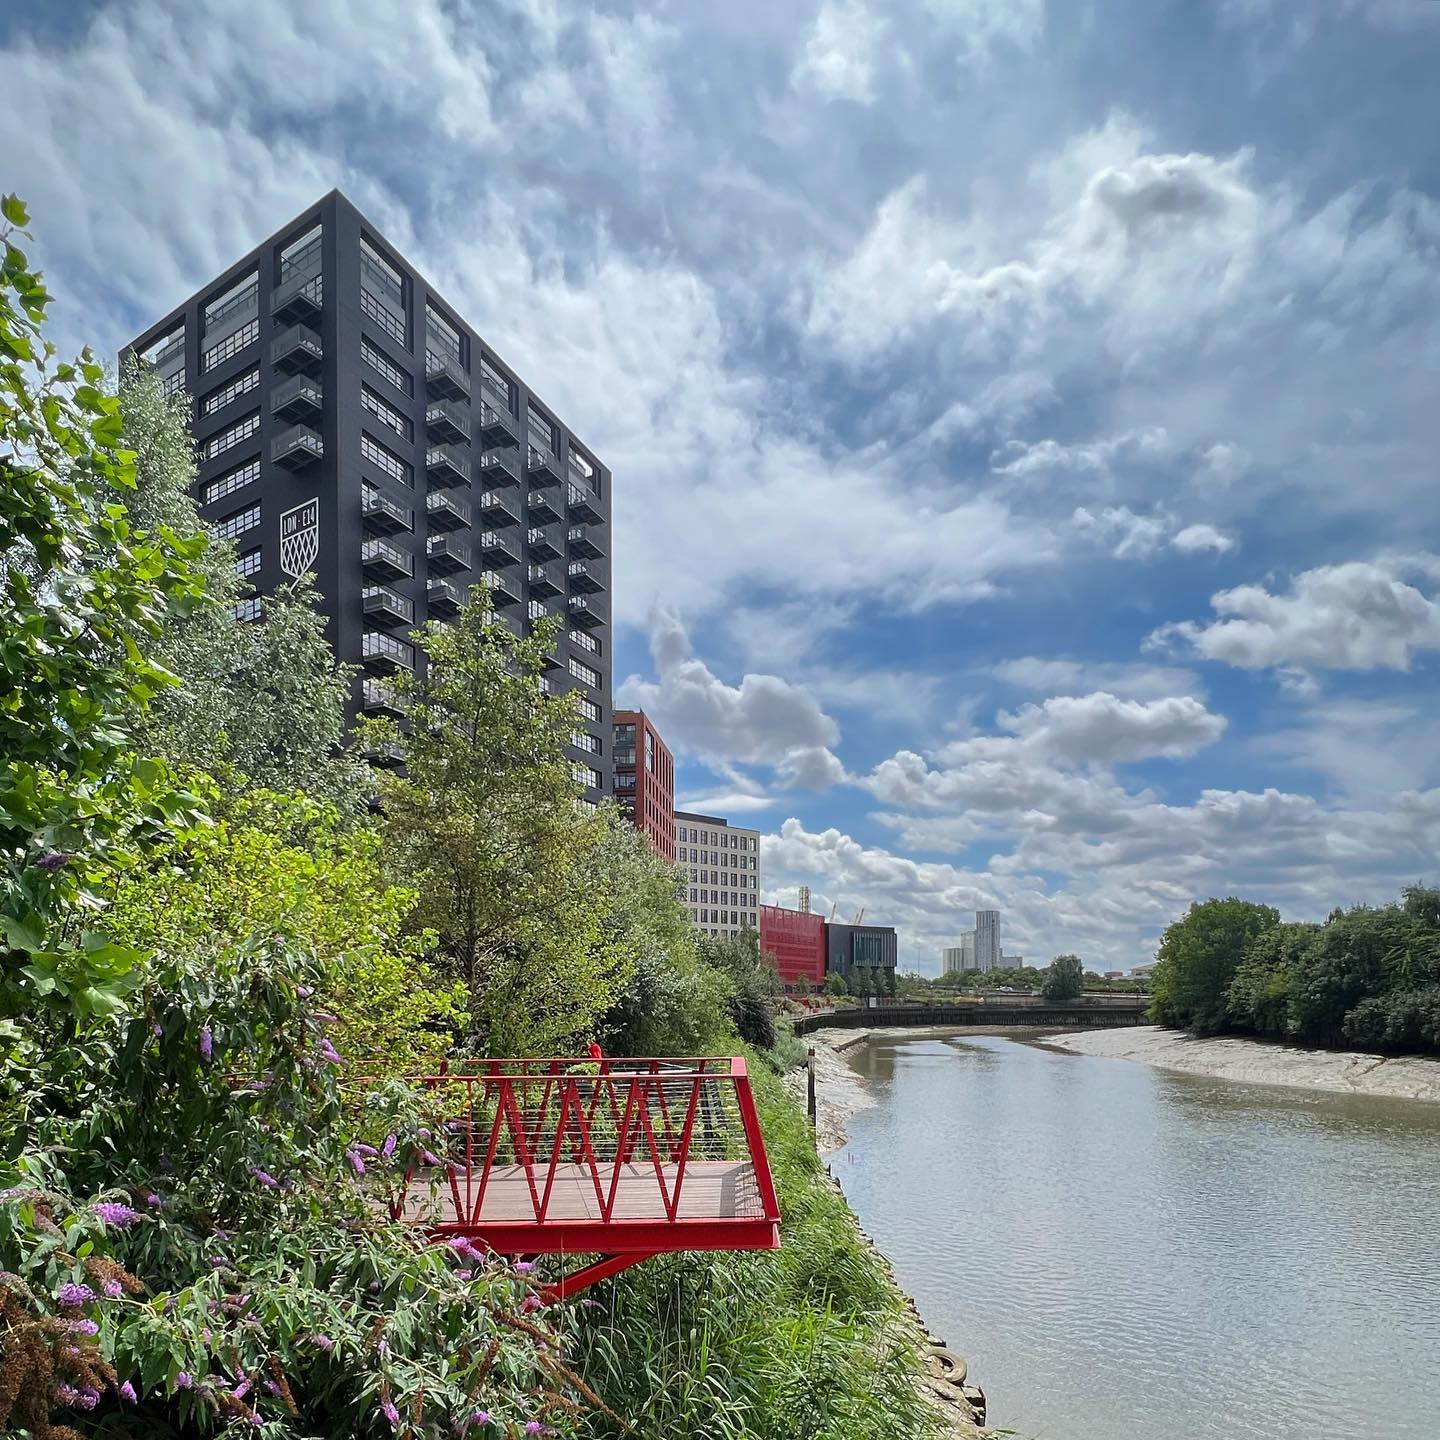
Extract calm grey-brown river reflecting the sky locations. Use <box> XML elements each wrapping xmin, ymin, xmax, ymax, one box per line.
<box><xmin>831</xmin><ymin>1035</ymin><xmax>1440</xmax><ymax>1440</ymax></box>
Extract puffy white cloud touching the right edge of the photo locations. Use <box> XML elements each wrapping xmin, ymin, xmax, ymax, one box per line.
<box><xmin>1152</xmin><ymin>560</ymin><xmax>1440</xmax><ymax>671</ymax></box>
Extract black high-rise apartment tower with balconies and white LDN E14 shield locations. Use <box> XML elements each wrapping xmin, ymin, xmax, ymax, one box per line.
<box><xmin>127</xmin><ymin>192</ymin><xmax>611</xmax><ymax>801</ymax></box>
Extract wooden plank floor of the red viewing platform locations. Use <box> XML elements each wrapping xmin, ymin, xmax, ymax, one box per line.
<box><xmin>400</xmin><ymin>1159</ymin><xmax>765</xmax><ymax>1228</ymax></box>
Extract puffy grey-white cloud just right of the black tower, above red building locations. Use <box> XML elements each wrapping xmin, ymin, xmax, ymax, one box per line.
<box><xmin>616</xmin><ymin>611</ymin><xmax>844</xmax><ymax>789</ymax></box>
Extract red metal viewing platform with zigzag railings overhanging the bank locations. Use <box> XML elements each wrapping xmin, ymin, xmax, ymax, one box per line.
<box><xmin>392</xmin><ymin>1058</ymin><xmax>780</xmax><ymax>1297</ymax></box>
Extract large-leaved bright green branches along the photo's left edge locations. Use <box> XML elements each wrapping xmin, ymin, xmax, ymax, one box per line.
<box><xmin>0</xmin><ymin>208</ymin><xmax>200</xmax><ymax>1020</ymax></box>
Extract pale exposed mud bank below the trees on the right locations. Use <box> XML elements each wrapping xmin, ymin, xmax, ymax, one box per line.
<box><xmin>1044</xmin><ymin>1025</ymin><xmax>1440</xmax><ymax>1102</ymax></box>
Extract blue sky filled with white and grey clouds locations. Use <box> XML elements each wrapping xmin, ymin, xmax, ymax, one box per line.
<box><xmin>0</xmin><ymin>0</ymin><xmax>1440</xmax><ymax>969</ymax></box>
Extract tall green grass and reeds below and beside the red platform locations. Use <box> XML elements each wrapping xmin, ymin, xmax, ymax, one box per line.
<box><xmin>572</xmin><ymin>1066</ymin><xmax>935</xmax><ymax>1440</ymax></box>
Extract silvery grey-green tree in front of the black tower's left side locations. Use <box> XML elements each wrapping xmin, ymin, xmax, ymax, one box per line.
<box><xmin>120</xmin><ymin>361</ymin><xmax>373</xmax><ymax>816</ymax></box>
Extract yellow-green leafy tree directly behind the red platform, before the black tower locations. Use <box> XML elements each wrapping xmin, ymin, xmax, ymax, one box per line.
<box><xmin>366</xmin><ymin>590</ymin><xmax>634</xmax><ymax>1054</ymax></box>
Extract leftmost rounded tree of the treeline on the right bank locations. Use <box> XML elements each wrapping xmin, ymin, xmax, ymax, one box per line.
<box><xmin>1151</xmin><ymin>897</ymin><xmax>1280</xmax><ymax>1032</ymax></box>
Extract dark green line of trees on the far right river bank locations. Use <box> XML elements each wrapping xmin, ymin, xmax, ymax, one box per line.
<box><xmin>1151</xmin><ymin>886</ymin><xmax>1440</xmax><ymax>1051</ymax></box>
